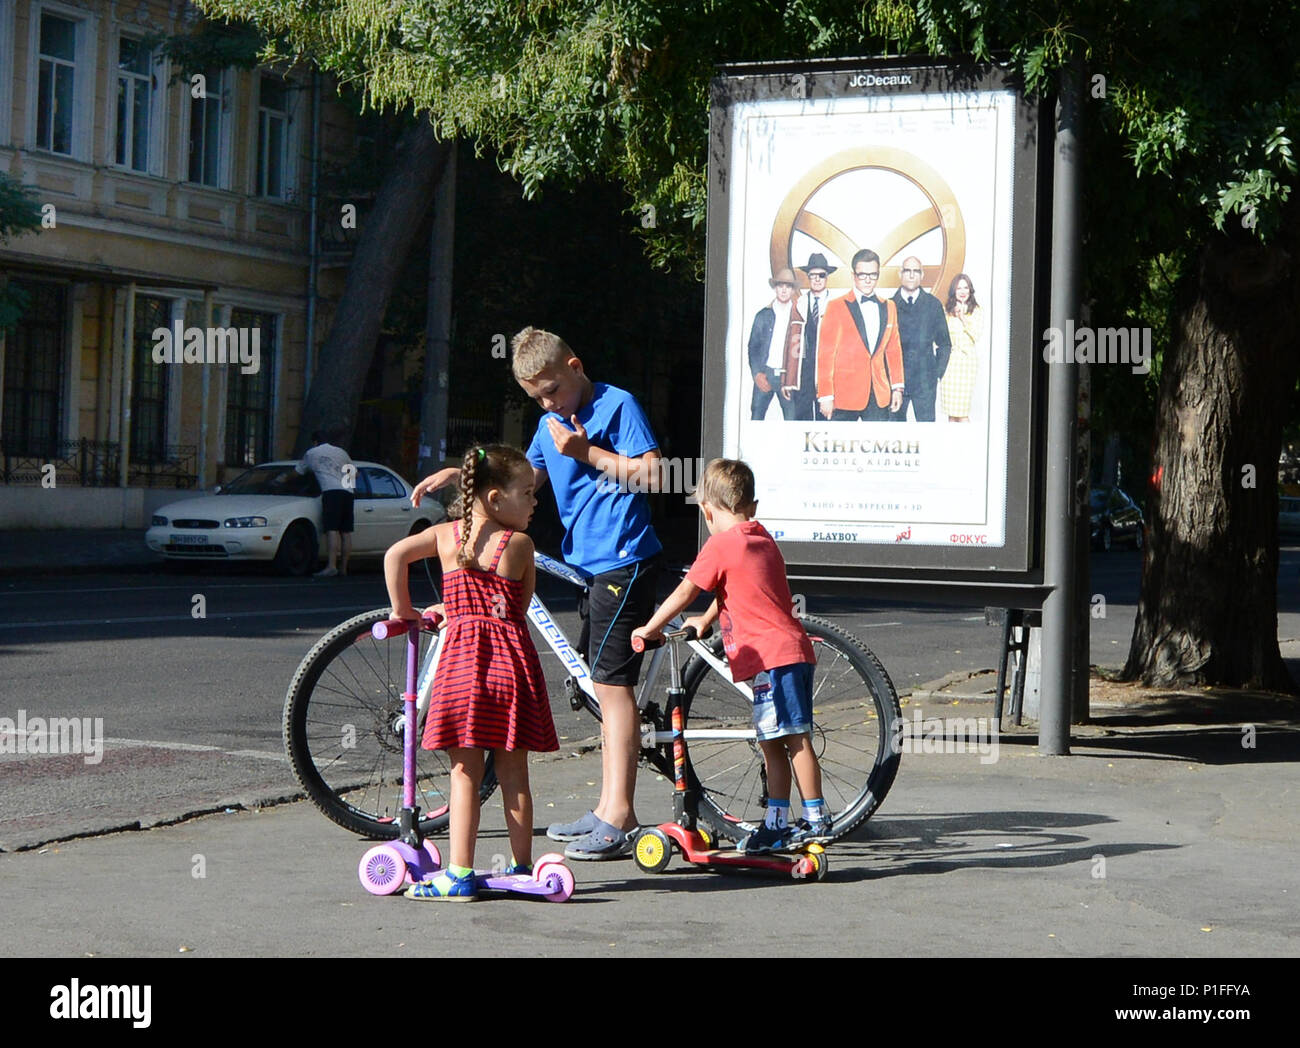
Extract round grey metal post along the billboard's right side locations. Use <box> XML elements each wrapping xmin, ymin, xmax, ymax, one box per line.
<box><xmin>1039</xmin><ymin>65</ymin><xmax>1083</xmax><ymax>755</ymax></box>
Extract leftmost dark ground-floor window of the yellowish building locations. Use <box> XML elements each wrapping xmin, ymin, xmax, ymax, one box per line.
<box><xmin>3</xmin><ymin>281</ymin><xmax>68</xmax><ymax>459</ymax></box>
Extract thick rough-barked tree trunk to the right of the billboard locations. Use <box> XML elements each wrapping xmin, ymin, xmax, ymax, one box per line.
<box><xmin>1123</xmin><ymin>205</ymin><xmax>1300</xmax><ymax>692</ymax></box>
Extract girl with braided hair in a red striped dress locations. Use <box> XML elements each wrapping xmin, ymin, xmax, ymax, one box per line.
<box><xmin>384</xmin><ymin>445</ymin><xmax>559</xmax><ymax>901</ymax></box>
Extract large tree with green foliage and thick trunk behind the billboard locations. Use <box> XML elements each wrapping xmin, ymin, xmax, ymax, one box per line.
<box><xmin>203</xmin><ymin>0</ymin><xmax>1300</xmax><ymax>688</ymax></box>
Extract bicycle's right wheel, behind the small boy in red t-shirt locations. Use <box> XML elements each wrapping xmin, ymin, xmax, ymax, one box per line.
<box><xmin>683</xmin><ymin>616</ymin><xmax>902</xmax><ymax>840</ymax></box>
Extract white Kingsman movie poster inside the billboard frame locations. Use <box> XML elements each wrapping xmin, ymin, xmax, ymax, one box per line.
<box><xmin>711</xmin><ymin>81</ymin><xmax>1023</xmax><ymax>547</ymax></box>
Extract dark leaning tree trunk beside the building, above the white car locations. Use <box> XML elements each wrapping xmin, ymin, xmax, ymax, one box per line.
<box><xmin>294</xmin><ymin>117</ymin><xmax>451</xmax><ymax>455</ymax></box>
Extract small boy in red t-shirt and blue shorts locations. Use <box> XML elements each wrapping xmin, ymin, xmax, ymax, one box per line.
<box><xmin>632</xmin><ymin>459</ymin><xmax>831</xmax><ymax>852</ymax></box>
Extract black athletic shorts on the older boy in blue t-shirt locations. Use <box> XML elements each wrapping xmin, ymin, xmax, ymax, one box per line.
<box><xmin>577</xmin><ymin>557</ymin><xmax>659</xmax><ymax>688</ymax></box>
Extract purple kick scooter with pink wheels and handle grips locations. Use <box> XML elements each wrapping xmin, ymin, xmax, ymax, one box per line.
<box><xmin>356</xmin><ymin>615</ymin><xmax>575</xmax><ymax>902</ymax></box>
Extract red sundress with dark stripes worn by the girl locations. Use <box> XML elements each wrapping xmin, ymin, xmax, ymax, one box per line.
<box><xmin>421</xmin><ymin>528</ymin><xmax>560</xmax><ymax>752</ymax></box>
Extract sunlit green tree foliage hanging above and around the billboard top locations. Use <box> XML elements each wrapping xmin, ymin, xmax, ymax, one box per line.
<box><xmin>202</xmin><ymin>0</ymin><xmax>1300</xmax><ymax>272</ymax></box>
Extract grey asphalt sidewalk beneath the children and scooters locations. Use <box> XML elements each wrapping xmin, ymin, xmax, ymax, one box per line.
<box><xmin>0</xmin><ymin>696</ymin><xmax>1300</xmax><ymax>957</ymax></box>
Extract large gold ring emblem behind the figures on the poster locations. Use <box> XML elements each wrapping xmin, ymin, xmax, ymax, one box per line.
<box><xmin>771</xmin><ymin>146</ymin><xmax>966</xmax><ymax>299</ymax></box>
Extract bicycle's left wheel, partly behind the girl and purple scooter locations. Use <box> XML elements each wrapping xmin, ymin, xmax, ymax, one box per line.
<box><xmin>285</xmin><ymin>607</ymin><xmax>497</xmax><ymax>840</ymax></box>
